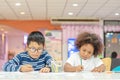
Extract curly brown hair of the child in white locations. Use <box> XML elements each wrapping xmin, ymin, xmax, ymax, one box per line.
<box><xmin>75</xmin><ymin>32</ymin><xmax>103</xmax><ymax>57</ymax></box>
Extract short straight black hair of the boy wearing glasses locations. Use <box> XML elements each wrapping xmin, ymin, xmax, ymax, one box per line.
<box><xmin>27</xmin><ymin>31</ymin><xmax>45</xmax><ymax>46</ymax></box>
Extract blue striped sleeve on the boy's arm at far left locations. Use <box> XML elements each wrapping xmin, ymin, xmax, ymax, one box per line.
<box><xmin>2</xmin><ymin>54</ymin><xmax>21</xmax><ymax>72</ymax></box>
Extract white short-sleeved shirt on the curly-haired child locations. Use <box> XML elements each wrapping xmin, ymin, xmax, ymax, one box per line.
<box><xmin>66</xmin><ymin>53</ymin><xmax>103</xmax><ymax>71</ymax></box>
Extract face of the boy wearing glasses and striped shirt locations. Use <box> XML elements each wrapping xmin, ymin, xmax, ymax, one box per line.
<box><xmin>27</xmin><ymin>41</ymin><xmax>44</xmax><ymax>59</ymax></box>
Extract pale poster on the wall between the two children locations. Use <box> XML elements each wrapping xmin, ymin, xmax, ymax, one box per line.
<box><xmin>45</xmin><ymin>30</ymin><xmax>62</xmax><ymax>61</ymax></box>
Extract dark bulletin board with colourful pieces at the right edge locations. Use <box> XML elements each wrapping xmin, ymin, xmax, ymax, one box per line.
<box><xmin>104</xmin><ymin>32</ymin><xmax>120</xmax><ymax>58</ymax></box>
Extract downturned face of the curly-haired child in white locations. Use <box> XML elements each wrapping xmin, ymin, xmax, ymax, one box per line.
<box><xmin>79</xmin><ymin>44</ymin><xmax>94</xmax><ymax>60</ymax></box>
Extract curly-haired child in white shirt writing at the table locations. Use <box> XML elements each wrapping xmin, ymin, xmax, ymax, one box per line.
<box><xmin>64</xmin><ymin>32</ymin><xmax>105</xmax><ymax>72</ymax></box>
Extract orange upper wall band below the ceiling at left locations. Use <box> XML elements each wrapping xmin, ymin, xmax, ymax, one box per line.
<box><xmin>0</xmin><ymin>20</ymin><xmax>61</xmax><ymax>33</ymax></box>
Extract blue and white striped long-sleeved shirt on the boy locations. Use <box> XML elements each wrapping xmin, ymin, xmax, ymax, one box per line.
<box><xmin>2</xmin><ymin>51</ymin><xmax>52</xmax><ymax>72</ymax></box>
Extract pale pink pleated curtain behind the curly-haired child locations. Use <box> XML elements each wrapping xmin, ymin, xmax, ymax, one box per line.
<box><xmin>62</xmin><ymin>24</ymin><xmax>103</xmax><ymax>42</ymax></box>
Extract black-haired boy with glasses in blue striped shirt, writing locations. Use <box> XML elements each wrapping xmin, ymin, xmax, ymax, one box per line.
<box><xmin>3</xmin><ymin>31</ymin><xmax>52</xmax><ymax>73</ymax></box>
